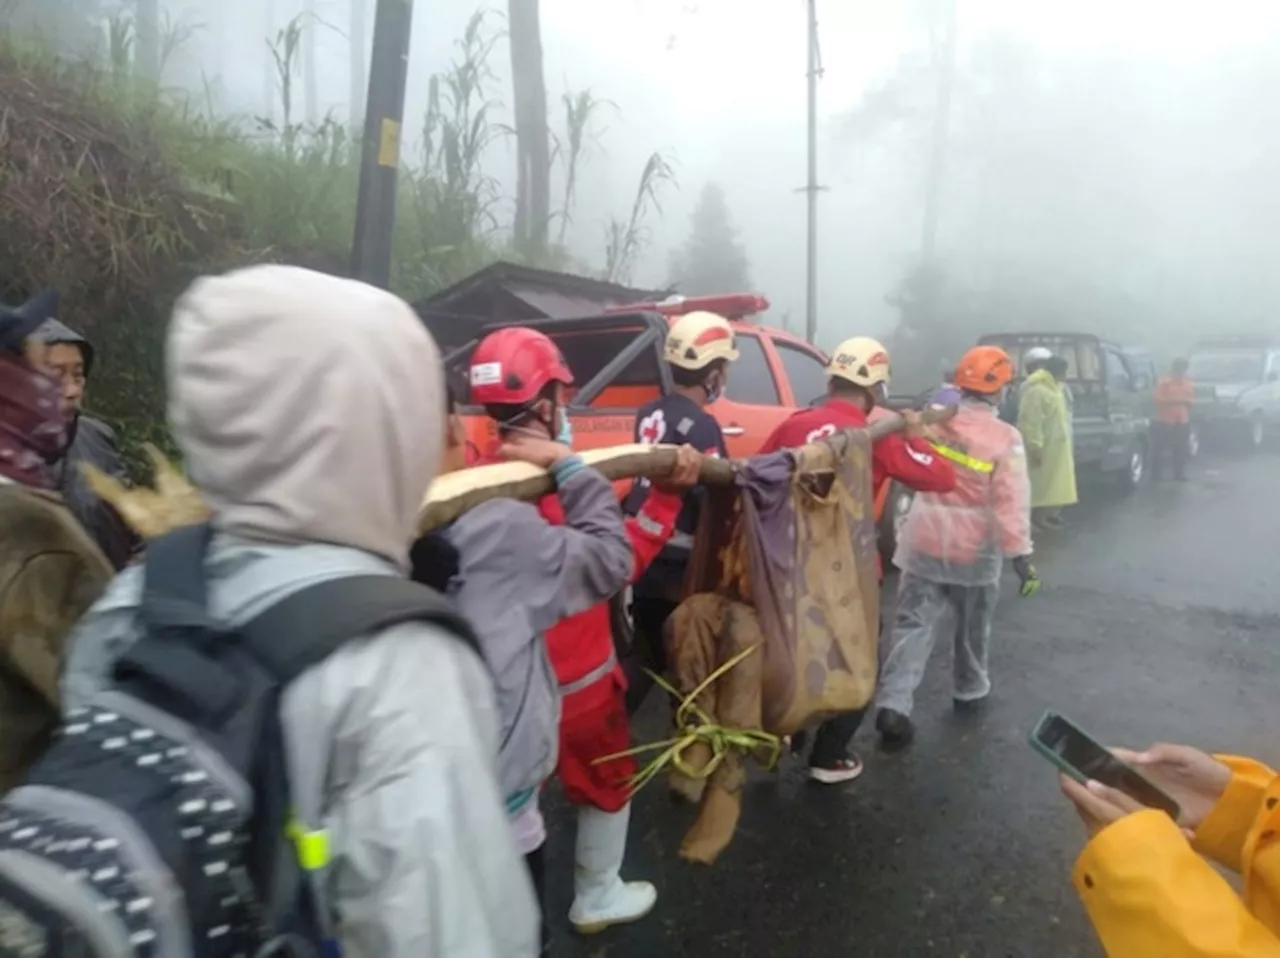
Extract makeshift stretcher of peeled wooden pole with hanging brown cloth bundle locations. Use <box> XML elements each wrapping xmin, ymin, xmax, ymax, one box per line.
<box><xmin>95</xmin><ymin>410</ymin><xmax>954</xmax><ymax>865</ymax></box>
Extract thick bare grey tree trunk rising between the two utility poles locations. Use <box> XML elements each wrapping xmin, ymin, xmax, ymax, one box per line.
<box><xmin>507</xmin><ymin>0</ymin><xmax>552</xmax><ymax>252</ymax></box>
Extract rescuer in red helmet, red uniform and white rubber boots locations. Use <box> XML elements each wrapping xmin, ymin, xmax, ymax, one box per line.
<box><xmin>461</xmin><ymin>328</ymin><xmax>701</xmax><ymax>934</ymax></box>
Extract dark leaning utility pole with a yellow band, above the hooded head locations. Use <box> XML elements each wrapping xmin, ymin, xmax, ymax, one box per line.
<box><xmin>351</xmin><ymin>0</ymin><xmax>413</xmax><ymax>289</ymax></box>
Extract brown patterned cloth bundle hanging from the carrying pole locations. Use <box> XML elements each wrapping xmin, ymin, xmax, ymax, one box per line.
<box><xmin>666</xmin><ymin>433</ymin><xmax>879</xmax><ymax>863</ymax></box>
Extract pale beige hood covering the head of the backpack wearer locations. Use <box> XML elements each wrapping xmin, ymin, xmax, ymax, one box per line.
<box><xmin>165</xmin><ymin>266</ymin><xmax>444</xmax><ymax>566</ymax></box>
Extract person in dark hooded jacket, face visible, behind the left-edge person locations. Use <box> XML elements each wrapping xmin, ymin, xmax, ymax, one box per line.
<box><xmin>36</xmin><ymin>313</ymin><xmax>140</xmax><ymax>569</ymax></box>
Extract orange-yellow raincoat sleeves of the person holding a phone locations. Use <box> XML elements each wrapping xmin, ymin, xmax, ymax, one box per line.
<box><xmin>1074</xmin><ymin>756</ymin><xmax>1280</xmax><ymax>958</ymax></box>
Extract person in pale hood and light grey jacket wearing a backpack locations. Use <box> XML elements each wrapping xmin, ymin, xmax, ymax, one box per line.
<box><xmin>63</xmin><ymin>265</ymin><xmax>539</xmax><ymax>958</ymax></box>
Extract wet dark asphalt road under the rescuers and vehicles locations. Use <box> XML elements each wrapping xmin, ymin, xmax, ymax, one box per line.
<box><xmin>548</xmin><ymin>457</ymin><xmax>1280</xmax><ymax>958</ymax></box>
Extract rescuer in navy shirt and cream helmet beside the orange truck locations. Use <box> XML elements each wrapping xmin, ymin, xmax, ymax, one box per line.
<box><xmin>623</xmin><ymin>310</ymin><xmax>737</xmax><ymax>713</ymax></box>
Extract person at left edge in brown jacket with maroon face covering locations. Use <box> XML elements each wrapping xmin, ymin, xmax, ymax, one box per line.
<box><xmin>0</xmin><ymin>295</ymin><xmax>111</xmax><ymax>794</ymax></box>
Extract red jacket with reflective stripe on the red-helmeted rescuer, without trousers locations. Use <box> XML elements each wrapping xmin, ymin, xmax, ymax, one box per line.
<box><xmin>538</xmin><ymin>488</ymin><xmax>685</xmax><ymax>719</ymax></box>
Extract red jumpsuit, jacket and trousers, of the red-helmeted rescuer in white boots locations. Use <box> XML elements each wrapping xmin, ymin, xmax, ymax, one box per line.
<box><xmin>538</xmin><ymin>488</ymin><xmax>684</xmax><ymax>812</ymax></box>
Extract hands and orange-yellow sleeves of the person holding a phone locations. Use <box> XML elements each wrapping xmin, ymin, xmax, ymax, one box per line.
<box><xmin>1061</xmin><ymin>745</ymin><xmax>1280</xmax><ymax>958</ymax></box>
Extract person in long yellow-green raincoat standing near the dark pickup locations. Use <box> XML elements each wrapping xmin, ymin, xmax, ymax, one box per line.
<box><xmin>1018</xmin><ymin>355</ymin><xmax>1079</xmax><ymax>529</ymax></box>
